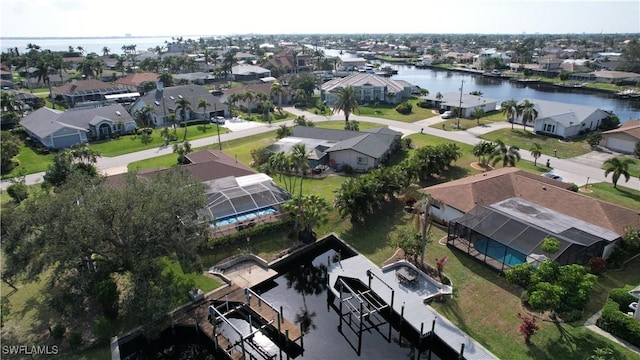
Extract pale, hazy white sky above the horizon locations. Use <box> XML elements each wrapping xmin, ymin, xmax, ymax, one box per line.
<box><xmin>0</xmin><ymin>0</ymin><xmax>640</xmax><ymax>37</ymax></box>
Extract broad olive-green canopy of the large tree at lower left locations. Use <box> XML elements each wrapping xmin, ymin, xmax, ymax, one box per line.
<box><xmin>2</xmin><ymin>169</ymin><xmax>207</xmax><ymax>336</ymax></box>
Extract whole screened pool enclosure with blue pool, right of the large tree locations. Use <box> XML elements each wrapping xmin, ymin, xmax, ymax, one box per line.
<box><xmin>204</xmin><ymin>174</ymin><xmax>291</xmax><ymax>228</ymax></box>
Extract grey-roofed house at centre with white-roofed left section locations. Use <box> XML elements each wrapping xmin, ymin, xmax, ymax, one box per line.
<box><xmin>267</xmin><ymin>126</ymin><xmax>402</xmax><ymax>172</ymax></box>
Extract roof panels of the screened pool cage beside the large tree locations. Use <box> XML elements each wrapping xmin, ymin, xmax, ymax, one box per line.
<box><xmin>204</xmin><ymin>174</ymin><xmax>291</xmax><ymax>220</ymax></box>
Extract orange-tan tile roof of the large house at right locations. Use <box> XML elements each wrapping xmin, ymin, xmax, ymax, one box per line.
<box><xmin>420</xmin><ymin>168</ymin><xmax>640</xmax><ymax>235</ymax></box>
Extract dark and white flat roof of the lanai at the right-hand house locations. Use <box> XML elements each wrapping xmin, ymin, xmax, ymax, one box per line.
<box><xmin>455</xmin><ymin>197</ymin><xmax>620</xmax><ymax>260</ymax></box>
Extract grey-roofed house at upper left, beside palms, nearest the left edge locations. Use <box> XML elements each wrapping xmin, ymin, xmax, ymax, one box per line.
<box><xmin>20</xmin><ymin>104</ymin><xmax>136</xmax><ymax>149</ymax></box>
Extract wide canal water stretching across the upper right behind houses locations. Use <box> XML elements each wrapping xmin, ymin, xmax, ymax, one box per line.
<box><xmin>324</xmin><ymin>49</ymin><xmax>640</xmax><ymax>123</ymax></box>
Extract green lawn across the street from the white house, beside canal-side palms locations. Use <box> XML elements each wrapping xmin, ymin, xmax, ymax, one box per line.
<box><xmin>480</xmin><ymin>129</ymin><xmax>591</xmax><ymax>159</ymax></box>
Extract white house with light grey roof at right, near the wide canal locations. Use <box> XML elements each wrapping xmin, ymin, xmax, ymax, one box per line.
<box><xmin>514</xmin><ymin>99</ymin><xmax>610</xmax><ymax>138</ymax></box>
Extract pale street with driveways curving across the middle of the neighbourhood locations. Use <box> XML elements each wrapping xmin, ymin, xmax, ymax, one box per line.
<box><xmin>0</xmin><ymin>107</ymin><xmax>640</xmax><ymax>190</ymax></box>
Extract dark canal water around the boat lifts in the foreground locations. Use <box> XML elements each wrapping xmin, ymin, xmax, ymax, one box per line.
<box><xmin>120</xmin><ymin>241</ymin><xmax>450</xmax><ymax>360</ymax></box>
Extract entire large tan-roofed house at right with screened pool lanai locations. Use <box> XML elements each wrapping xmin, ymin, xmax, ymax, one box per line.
<box><xmin>420</xmin><ymin>167</ymin><xmax>640</xmax><ymax>271</ymax></box>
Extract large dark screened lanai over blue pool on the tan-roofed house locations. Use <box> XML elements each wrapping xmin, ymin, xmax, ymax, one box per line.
<box><xmin>447</xmin><ymin>198</ymin><xmax>620</xmax><ymax>271</ymax></box>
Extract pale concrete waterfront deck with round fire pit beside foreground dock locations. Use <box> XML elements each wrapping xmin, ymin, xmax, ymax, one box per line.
<box><xmin>328</xmin><ymin>255</ymin><xmax>498</xmax><ymax>360</ymax></box>
